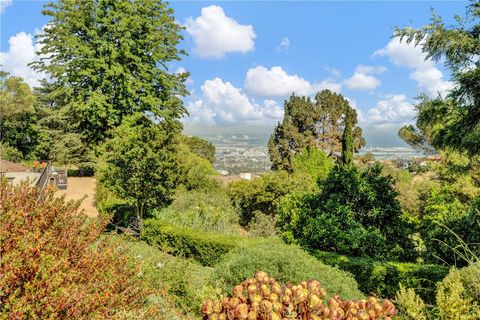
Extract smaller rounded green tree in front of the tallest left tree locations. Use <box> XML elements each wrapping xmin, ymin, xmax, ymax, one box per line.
<box><xmin>100</xmin><ymin>114</ymin><xmax>179</xmax><ymax>220</ymax></box>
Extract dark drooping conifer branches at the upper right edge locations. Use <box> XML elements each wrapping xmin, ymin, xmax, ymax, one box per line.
<box><xmin>395</xmin><ymin>1</ymin><xmax>480</xmax><ymax>156</ymax></box>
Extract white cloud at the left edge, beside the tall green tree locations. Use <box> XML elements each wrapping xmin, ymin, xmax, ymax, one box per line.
<box><xmin>0</xmin><ymin>32</ymin><xmax>45</xmax><ymax>87</ymax></box>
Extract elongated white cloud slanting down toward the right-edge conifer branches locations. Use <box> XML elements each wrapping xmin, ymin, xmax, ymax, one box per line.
<box><xmin>374</xmin><ymin>38</ymin><xmax>453</xmax><ymax>97</ymax></box>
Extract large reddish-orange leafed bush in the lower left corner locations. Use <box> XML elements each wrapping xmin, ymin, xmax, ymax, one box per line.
<box><xmin>0</xmin><ymin>181</ymin><xmax>146</xmax><ymax>319</ymax></box>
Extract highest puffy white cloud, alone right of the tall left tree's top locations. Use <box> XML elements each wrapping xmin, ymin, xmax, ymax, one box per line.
<box><xmin>185</xmin><ymin>5</ymin><xmax>256</xmax><ymax>58</ymax></box>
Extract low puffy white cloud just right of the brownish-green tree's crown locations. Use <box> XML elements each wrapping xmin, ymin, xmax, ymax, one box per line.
<box><xmin>365</xmin><ymin>94</ymin><xmax>416</xmax><ymax>125</ymax></box>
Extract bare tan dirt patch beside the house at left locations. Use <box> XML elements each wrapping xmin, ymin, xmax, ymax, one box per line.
<box><xmin>57</xmin><ymin>177</ymin><xmax>98</xmax><ymax>217</ymax></box>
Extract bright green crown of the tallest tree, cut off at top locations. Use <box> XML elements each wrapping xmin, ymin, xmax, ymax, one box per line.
<box><xmin>32</xmin><ymin>0</ymin><xmax>188</xmax><ymax>144</ymax></box>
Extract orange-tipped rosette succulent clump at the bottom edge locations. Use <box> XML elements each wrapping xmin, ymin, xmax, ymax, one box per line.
<box><xmin>201</xmin><ymin>272</ymin><xmax>396</xmax><ymax>320</ymax></box>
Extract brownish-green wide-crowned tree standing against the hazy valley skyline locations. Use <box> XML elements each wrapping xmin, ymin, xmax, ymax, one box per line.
<box><xmin>268</xmin><ymin>90</ymin><xmax>365</xmax><ymax>171</ymax></box>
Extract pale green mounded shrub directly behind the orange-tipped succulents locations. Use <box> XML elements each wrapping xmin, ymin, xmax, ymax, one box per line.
<box><xmin>212</xmin><ymin>240</ymin><xmax>363</xmax><ymax>299</ymax></box>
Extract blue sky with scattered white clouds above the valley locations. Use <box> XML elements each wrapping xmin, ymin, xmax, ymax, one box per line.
<box><xmin>0</xmin><ymin>0</ymin><xmax>468</xmax><ymax>145</ymax></box>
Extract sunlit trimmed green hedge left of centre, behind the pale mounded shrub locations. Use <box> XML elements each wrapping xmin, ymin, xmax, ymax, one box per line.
<box><xmin>142</xmin><ymin>219</ymin><xmax>269</xmax><ymax>267</ymax></box>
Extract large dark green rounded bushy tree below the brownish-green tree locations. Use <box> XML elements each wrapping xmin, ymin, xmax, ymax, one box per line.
<box><xmin>279</xmin><ymin>165</ymin><xmax>413</xmax><ymax>260</ymax></box>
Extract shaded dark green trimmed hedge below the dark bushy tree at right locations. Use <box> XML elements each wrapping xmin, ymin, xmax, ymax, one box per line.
<box><xmin>310</xmin><ymin>251</ymin><xmax>449</xmax><ymax>303</ymax></box>
